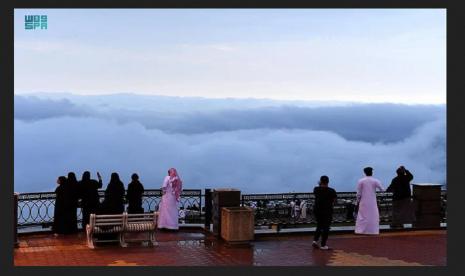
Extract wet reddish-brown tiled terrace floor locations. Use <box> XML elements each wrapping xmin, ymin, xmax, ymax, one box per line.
<box><xmin>14</xmin><ymin>229</ymin><xmax>447</xmax><ymax>266</ymax></box>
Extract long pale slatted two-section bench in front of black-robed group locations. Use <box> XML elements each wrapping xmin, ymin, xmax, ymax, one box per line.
<box><xmin>86</xmin><ymin>212</ymin><xmax>158</xmax><ymax>248</ymax></box>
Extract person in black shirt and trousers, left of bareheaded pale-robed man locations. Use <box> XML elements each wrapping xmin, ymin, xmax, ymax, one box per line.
<box><xmin>312</xmin><ymin>175</ymin><xmax>337</xmax><ymax>250</ymax></box>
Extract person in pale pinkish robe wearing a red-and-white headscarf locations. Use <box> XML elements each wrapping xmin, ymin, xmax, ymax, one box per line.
<box><xmin>158</xmin><ymin>168</ymin><xmax>182</xmax><ymax>230</ymax></box>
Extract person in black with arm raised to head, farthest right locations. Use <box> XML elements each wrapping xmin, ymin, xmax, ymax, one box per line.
<box><xmin>386</xmin><ymin>166</ymin><xmax>414</xmax><ymax>228</ymax></box>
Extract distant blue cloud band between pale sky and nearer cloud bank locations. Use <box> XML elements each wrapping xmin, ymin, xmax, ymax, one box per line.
<box><xmin>15</xmin><ymin>94</ymin><xmax>445</xmax><ymax>142</ymax></box>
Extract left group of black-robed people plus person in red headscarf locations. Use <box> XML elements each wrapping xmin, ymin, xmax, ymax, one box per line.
<box><xmin>52</xmin><ymin>168</ymin><xmax>182</xmax><ymax>234</ymax></box>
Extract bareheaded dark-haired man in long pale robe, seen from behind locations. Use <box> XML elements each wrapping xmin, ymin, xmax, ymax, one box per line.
<box><xmin>355</xmin><ymin>167</ymin><xmax>383</xmax><ymax>235</ymax></box>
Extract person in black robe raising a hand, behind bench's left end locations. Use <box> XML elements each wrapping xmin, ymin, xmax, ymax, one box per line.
<box><xmin>79</xmin><ymin>171</ymin><xmax>102</xmax><ymax>229</ymax></box>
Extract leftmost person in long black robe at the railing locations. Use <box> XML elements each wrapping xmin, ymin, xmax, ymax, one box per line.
<box><xmin>52</xmin><ymin>176</ymin><xmax>75</xmax><ymax>234</ymax></box>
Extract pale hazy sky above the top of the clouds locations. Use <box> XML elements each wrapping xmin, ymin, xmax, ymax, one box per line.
<box><xmin>14</xmin><ymin>9</ymin><xmax>446</xmax><ymax>104</ymax></box>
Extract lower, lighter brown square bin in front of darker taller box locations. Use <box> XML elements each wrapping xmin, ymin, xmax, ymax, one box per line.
<box><xmin>221</xmin><ymin>207</ymin><xmax>255</xmax><ymax>243</ymax></box>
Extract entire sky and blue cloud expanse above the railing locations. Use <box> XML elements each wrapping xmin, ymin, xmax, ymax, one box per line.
<box><xmin>14</xmin><ymin>9</ymin><xmax>447</xmax><ymax>193</ymax></box>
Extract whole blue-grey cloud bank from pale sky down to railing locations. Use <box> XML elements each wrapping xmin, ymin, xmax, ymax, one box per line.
<box><xmin>15</xmin><ymin>94</ymin><xmax>446</xmax><ymax>193</ymax></box>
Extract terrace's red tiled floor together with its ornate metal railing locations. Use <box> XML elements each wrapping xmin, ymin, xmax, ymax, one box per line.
<box><xmin>14</xmin><ymin>189</ymin><xmax>447</xmax><ymax>266</ymax></box>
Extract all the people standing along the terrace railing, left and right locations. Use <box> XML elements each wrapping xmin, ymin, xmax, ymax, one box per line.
<box><xmin>53</xmin><ymin>166</ymin><xmax>413</xmax><ymax>249</ymax></box>
